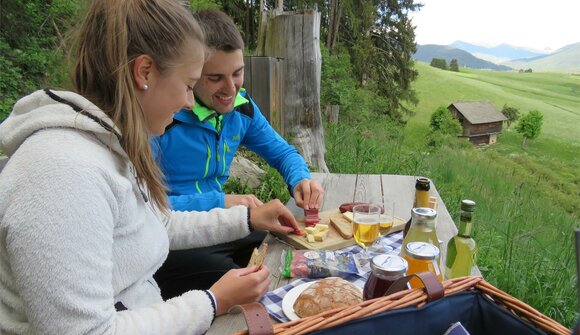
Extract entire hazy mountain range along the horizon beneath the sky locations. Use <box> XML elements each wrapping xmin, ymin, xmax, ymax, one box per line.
<box><xmin>413</xmin><ymin>41</ymin><xmax>580</xmax><ymax>73</ymax></box>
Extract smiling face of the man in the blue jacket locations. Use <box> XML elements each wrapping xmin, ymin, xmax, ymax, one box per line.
<box><xmin>193</xmin><ymin>50</ymin><xmax>244</xmax><ymax>114</ymax></box>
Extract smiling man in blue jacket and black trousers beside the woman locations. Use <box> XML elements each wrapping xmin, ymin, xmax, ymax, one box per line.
<box><xmin>152</xmin><ymin>10</ymin><xmax>324</xmax><ymax>299</ymax></box>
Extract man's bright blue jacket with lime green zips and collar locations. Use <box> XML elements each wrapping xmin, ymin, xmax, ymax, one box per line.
<box><xmin>151</xmin><ymin>89</ymin><xmax>311</xmax><ymax>211</ymax></box>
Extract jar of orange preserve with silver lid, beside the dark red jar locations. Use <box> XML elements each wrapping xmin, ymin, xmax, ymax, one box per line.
<box><xmin>403</xmin><ymin>242</ymin><xmax>443</xmax><ymax>288</ymax></box>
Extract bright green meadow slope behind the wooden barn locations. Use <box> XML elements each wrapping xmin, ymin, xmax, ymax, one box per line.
<box><xmin>409</xmin><ymin>62</ymin><xmax>580</xmax><ymax>145</ymax></box>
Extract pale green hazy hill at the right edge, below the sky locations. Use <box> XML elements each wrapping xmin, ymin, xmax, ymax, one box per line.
<box><xmin>504</xmin><ymin>42</ymin><xmax>580</xmax><ymax>73</ymax></box>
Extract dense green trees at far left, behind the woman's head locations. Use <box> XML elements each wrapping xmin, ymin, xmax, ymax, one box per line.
<box><xmin>0</xmin><ymin>0</ymin><xmax>80</xmax><ymax>121</ymax></box>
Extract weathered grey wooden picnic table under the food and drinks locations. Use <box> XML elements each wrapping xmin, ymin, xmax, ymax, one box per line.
<box><xmin>207</xmin><ymin>173</ymin><xmax>457</xmax><ymax>334</ymax></box>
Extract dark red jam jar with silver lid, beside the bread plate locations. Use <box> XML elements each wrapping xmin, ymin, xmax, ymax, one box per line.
<box><xmin>363</xmin><ymin>254</ymin><xmax>408</xmax><ymax>300</ymax></box>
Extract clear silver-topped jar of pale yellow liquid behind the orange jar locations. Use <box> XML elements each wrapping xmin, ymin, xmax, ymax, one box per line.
<box><xmin>401</xmin><ymin>207</ymin><xmax>439</xmax><ymax>264</ymax></box>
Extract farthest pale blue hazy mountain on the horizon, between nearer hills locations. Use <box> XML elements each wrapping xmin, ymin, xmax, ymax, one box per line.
<box><xmin>450</xmin><ymin>41</ymin><xmax>545</xmax><ymax>63</ymax></box>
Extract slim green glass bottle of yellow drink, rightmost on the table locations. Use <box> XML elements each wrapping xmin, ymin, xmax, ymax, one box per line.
<box><xmin>445</xmin><ymin>199</ymin><xmax>477</xmax><ymax>279</ymax></box>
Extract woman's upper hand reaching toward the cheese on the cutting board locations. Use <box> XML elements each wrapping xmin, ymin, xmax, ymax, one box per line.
<box><xmin>250</xmin><ymin>199</ymin><xmax>300</xmax><ymax>234</ymax></box>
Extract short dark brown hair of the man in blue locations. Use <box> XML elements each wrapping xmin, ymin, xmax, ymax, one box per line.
<box><xmin>194</xmin><ymin>9</ymin><xmax>244</xmax><ymax>52</ymax></box>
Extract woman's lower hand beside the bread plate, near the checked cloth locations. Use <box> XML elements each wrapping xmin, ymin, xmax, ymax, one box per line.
<box><xmin>209</xmin><ymin>265</ymin><xmax>271</xmax><ymax>316</ymax></box>
